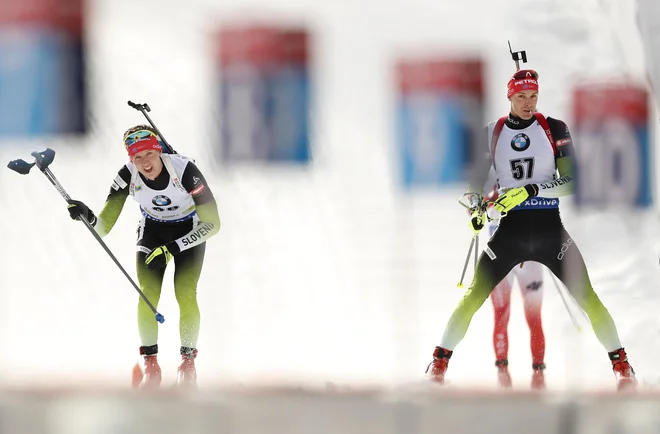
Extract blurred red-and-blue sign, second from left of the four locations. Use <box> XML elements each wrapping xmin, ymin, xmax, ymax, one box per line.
<box><xmin>217</xmin><ymin>26</ymin><xmax>310</xmax><ymax>163</ymax></box>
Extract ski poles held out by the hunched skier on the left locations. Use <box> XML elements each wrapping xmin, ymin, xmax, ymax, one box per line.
<box><xmin>7</xmin><ymin>148</ymin><xmax>165</xmax><ymax>323</ymax></box>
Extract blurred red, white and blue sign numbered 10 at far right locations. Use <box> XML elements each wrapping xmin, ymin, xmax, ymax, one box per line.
<box><xmin>571</xmin><ymin>82</ymin><xmax>653</xmax><ymax>207</ymax></box>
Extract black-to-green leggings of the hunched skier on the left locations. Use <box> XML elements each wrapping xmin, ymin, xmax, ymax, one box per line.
<box><xmin>136</xmin><ymin>243</ymin><xmax>206</xmax><ymax>348</ymax></box>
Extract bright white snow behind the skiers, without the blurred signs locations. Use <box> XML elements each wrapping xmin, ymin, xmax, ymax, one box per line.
<box><xmin>0</xmin><ymin>0</ymin><xmax>660</xmax><ymax>390</ymax></box>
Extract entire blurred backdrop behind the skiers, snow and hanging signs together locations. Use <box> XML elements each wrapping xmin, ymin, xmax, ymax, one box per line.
<box><xmin>0</xmin><ymin>0</ymin><xmax>660</xmax><ymax>433</ymax></box>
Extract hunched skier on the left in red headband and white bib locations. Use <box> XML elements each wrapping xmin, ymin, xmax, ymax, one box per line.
<box><xmin>69</xmin><ymin>125</ymin><xmax>220</xmax><ymax>388</ymax></box>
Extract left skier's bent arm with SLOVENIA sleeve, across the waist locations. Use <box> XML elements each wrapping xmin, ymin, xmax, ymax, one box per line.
<box><xmin>168</xmin><ymin>162</ymin><xmax>220</xmax><ymax>253</ymax></box>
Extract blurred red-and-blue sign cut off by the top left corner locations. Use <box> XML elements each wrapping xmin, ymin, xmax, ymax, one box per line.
<box><xmin>0</xmin><ymin>0</ymin><xmax>86</xmax><ymax>138</ymax></box>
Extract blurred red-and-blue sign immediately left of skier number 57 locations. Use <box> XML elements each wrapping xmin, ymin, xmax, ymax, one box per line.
<box><xmin>396</xmin><ymin>57</ymin><xmax>488</xmax><ymax>187</ymax></box>
